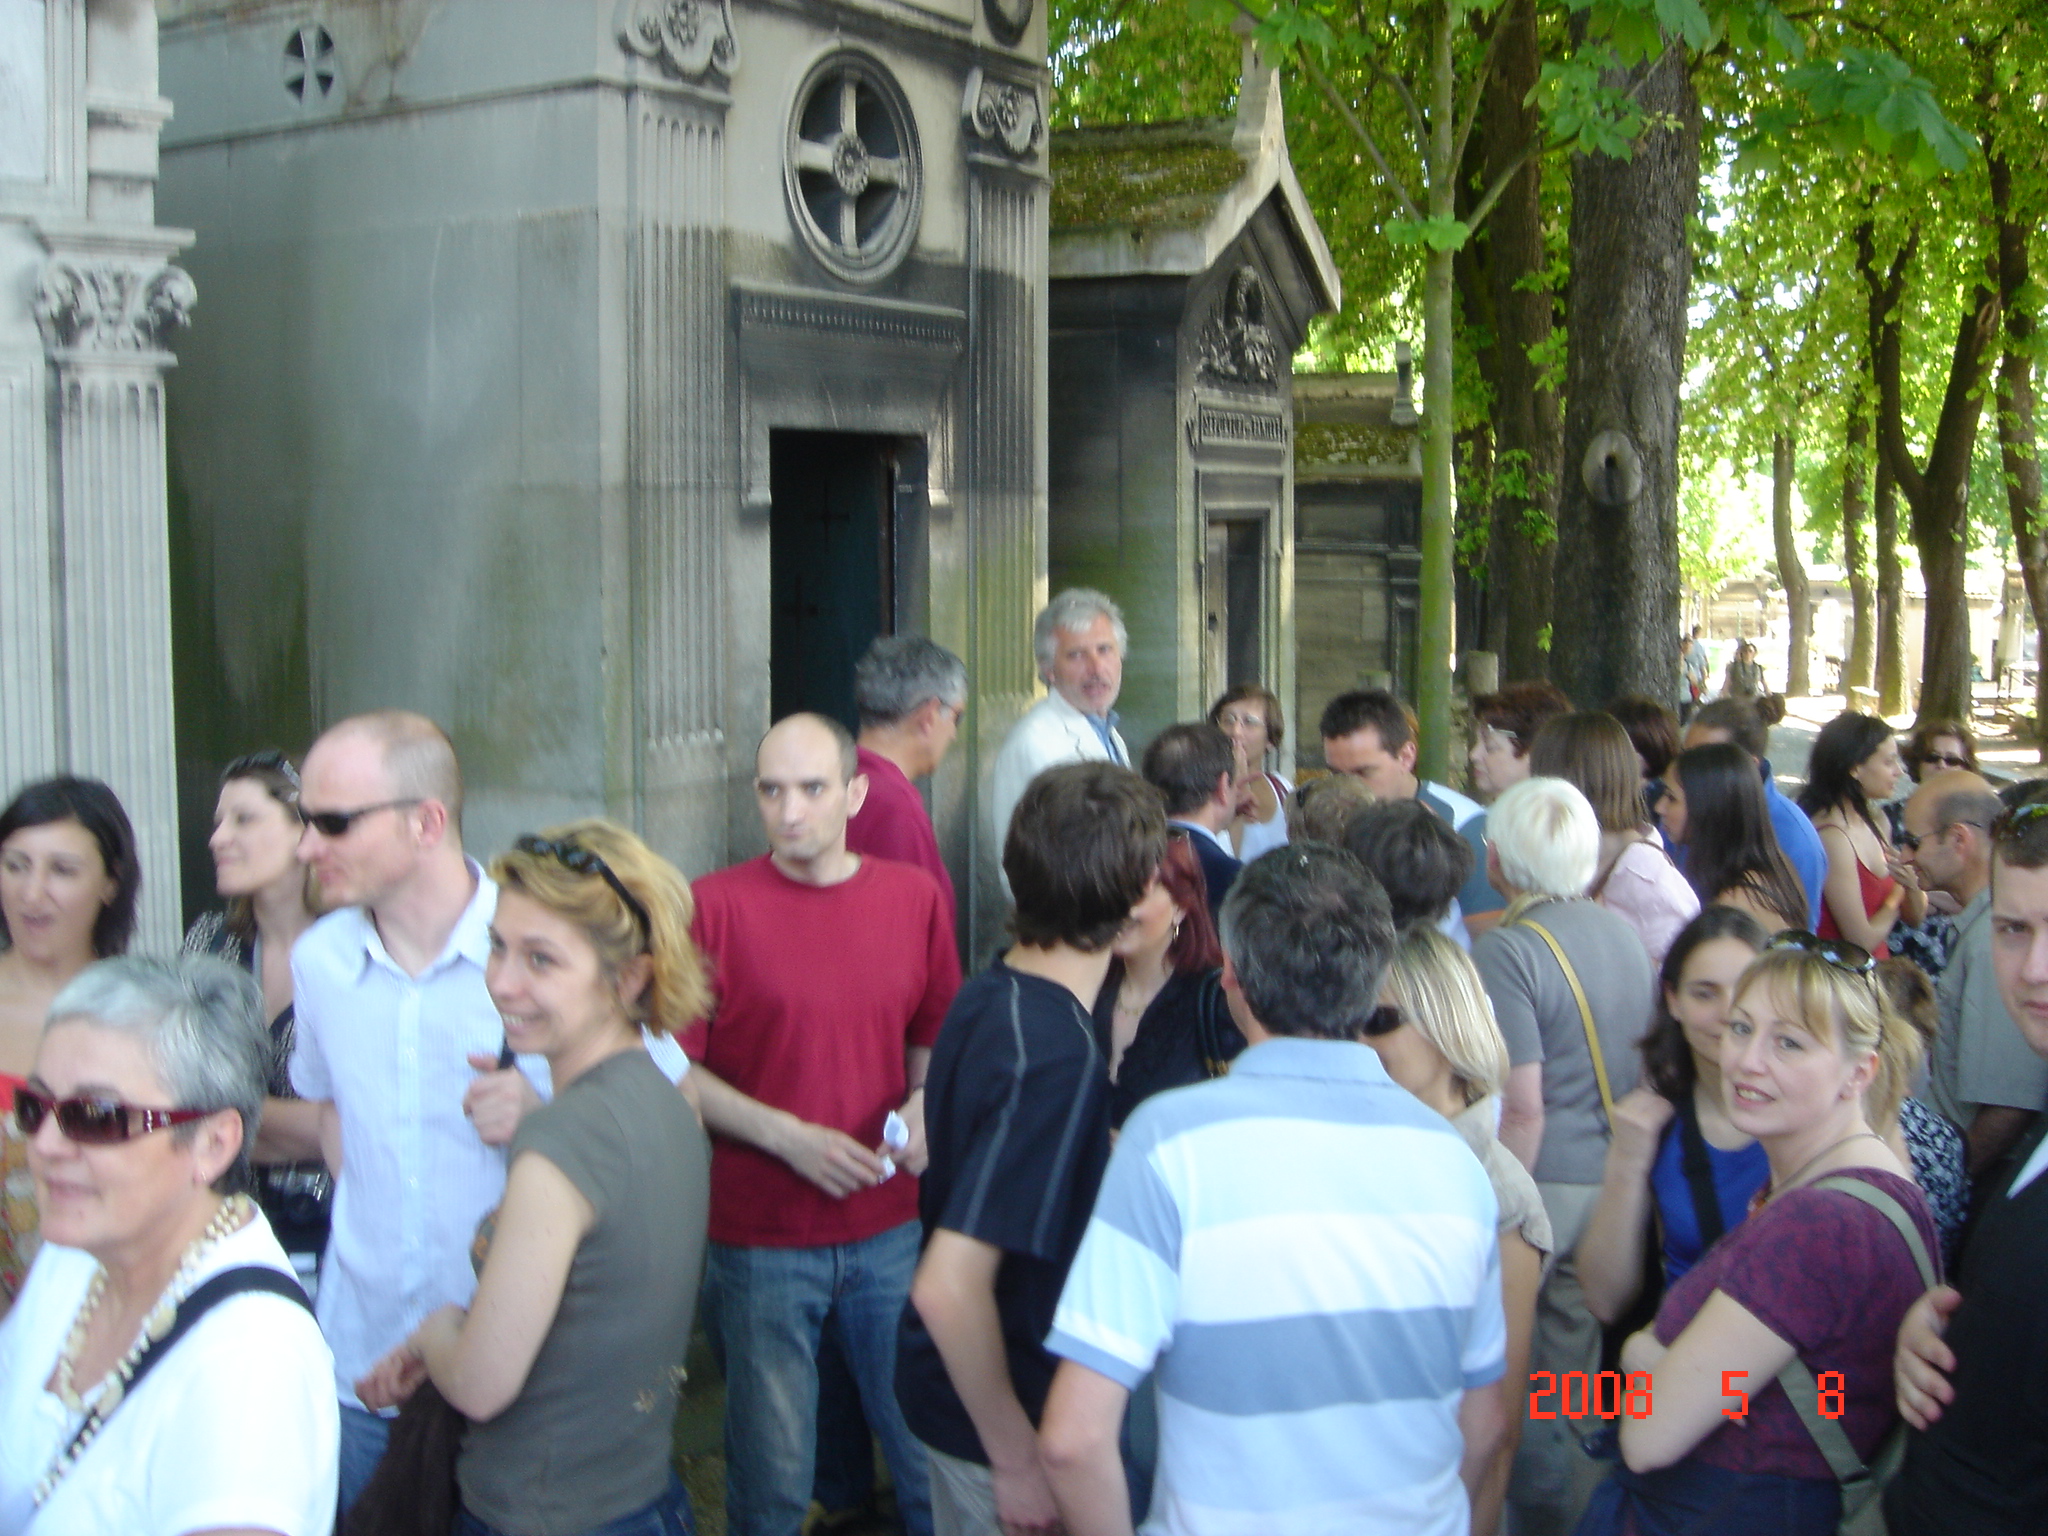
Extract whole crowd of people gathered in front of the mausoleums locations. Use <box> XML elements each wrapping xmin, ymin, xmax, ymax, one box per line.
<box><xmin>0</xmin><ymin>590</ymin><xmax>2048</xmax><ymax>1536</ymax></box>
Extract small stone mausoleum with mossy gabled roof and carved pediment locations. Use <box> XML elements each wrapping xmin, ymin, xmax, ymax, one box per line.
<box><xmin>1047</xmin><ymin>45</ymin><xmax>1339</xmax><ymax>770</ymax></box>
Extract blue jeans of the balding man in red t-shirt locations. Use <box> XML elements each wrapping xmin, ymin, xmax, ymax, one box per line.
<box><xmin>702</xmin><ymin>1221</ymin><xmax>932</xmax><ymax>1536</ymax></box>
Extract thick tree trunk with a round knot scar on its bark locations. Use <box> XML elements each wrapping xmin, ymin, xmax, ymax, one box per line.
<box><xmin>1550</xmin><ymin>47</ymin><xmax>1700</xmax><ymax>707</ymax></box>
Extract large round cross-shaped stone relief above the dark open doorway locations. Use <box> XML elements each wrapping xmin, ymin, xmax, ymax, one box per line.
<box><xmin>782</xmin><ymin>49</ymin><xmax>924</xmax><ymax>283</ymax></box>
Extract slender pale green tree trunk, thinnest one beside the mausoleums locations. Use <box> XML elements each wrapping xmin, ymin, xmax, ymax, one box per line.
<box><xmin>1415</xmin><ymin>0</ymin><xmax>1458</xmax><ymax>780</ymax></box>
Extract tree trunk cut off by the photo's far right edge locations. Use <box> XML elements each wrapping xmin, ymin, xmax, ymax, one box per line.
<box><xmin>1987</xmin><ymin>150</ymin><xmax>2048</xmax><ymax>762</ymax></box>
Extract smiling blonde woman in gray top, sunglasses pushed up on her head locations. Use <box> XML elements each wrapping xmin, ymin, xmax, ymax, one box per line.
<box><xmin>356</xmin><ymin>821</ymin><xmax>711</xmax><ymax>1536</ymax></box>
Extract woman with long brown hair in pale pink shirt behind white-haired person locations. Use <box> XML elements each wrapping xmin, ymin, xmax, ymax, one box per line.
<box><xmin>1530</xmin><ymin>711</ymin><xmax>1700</xmax><ymax>965</ymax></box>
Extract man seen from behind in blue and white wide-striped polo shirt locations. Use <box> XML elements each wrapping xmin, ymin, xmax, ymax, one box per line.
<box><xmin>1040</xmin><ymin>844</ymin><xmax>1507</xmax><ymax>1536</ymax></box>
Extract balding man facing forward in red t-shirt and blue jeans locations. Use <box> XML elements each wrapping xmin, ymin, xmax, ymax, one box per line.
<box><xmin>682</xmin><ymin>715</ymin><xmax>961</xmax><ymax>1536</ymax></box>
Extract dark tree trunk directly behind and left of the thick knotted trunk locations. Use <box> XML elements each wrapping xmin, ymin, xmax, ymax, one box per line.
<box><xmin>1475</xmin><ymin>0</ymin><xmax>1563</xmax><ymax>682</ymax></box>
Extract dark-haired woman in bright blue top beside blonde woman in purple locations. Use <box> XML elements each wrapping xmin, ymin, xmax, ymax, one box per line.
<box><xmin>1579</xmin><ymin>907</ymin><xmax>1772</xmax><ymax>1323</ymax></box>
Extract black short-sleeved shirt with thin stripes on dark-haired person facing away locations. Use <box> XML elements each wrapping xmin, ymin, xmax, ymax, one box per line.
<box><xmin>897</xmin><ymin>961</ymin><xmax>1110</xmax><ymax>1464</ymax></box>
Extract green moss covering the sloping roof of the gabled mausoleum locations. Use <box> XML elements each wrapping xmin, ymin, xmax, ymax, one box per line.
<box><xmin>1051</xmin><ymin>119</ymin><xmax>1245</xmax><ymax>229</ymax></box>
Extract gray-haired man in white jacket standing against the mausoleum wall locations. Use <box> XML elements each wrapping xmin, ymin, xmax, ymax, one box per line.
<box><xmin>989</xmin><ymin>586</ymin><xmax>1130</xmax><ymax>848</ymax></box>
